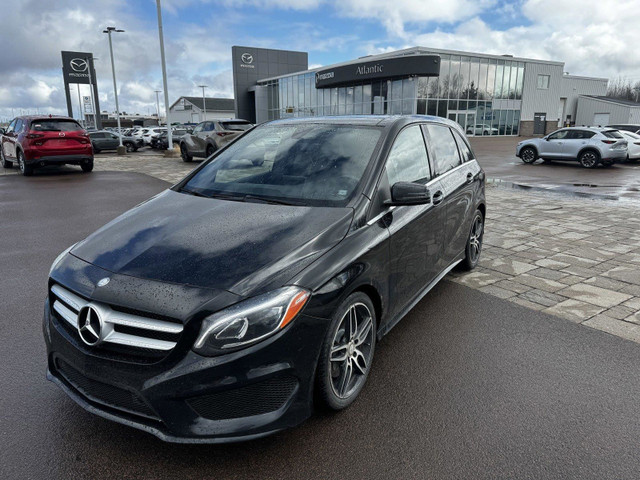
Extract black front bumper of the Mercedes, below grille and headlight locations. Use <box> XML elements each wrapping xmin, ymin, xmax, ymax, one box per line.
<box><xmin>44</xmin><ymin>301</ymin><xmax>328</xmax><ymax>443</ymax></box>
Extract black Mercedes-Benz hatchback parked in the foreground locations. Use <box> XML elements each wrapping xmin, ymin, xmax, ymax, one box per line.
<box><xmin>44</xmin><ymin>116</ymin><xmax>485</xmax><ymax>442</ymax></box>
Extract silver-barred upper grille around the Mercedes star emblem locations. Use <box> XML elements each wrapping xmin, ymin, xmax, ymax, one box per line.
<box><xmin>50</xmin><ymin>284</ymin><xmax>184</xmax><ymax>361</ymax></box>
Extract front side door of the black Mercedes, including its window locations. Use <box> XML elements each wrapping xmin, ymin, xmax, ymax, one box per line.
<box><xmin>382</xmin><ymin>125</ymin><xmax>443</xmax><ymax>317</ymax></box>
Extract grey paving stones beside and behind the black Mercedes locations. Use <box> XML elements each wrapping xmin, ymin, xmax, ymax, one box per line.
<box><xmin>5</xmin><ymin>152</ymin><xmax>640</xmax><ymax>343</ymax></box>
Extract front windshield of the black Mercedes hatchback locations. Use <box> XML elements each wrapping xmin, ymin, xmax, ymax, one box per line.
<box><xmin>182</xmin><ymin>124</ymin><xmax>380</xmax><ymax>206</ymax></box>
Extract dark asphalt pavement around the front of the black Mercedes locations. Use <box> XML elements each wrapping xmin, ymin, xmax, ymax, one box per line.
<box><xmin>0</xmin><ymin>170</ymin><xmax>640</xmax><ymax>479</ymax></box>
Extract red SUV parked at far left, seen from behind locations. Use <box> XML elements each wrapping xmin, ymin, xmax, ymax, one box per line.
<box><xmin>0</xmin><ymin>115</ymin><xmax>93</xmax><ymax>176</ymax></box>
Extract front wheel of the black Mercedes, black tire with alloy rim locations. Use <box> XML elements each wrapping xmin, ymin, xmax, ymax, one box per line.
<box><xmin>316</xmin><ymin>292</ymin><xmax>377</xmax><ymax>411</ymax></box>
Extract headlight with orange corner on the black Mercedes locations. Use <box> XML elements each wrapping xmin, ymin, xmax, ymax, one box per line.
<box><xmin>193</xmin><ymin>286</ymin><xmax>311</xmax><ymax>356</ymax></box>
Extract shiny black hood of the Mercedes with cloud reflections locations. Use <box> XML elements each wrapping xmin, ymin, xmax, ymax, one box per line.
<box><xmin>71</xmin><ymin>190</ymin><xmax>353</xmax><ymax>296</ymax></box>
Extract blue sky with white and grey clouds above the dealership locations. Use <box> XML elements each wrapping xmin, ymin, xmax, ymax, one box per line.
<box><xmin>0</xmin><ymin>0</ymin><xmax>640</xmax><ymax>120</ymax></box>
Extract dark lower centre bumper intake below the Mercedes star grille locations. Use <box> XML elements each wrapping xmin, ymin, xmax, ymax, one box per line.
<box><xmin>55</xmin><ymin>359</ymin><xmax>159</xmax><ymax>420</ymax></box>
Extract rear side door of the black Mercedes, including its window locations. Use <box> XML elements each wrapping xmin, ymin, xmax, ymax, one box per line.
<box><xmin>424</xmin><ymin>123</ymin><xmax>480</xmax><ymax>274</ymax></box>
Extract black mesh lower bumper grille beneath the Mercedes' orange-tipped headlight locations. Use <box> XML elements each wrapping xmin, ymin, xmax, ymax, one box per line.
<box><xmin>187</xmin><ymin>376</ymin><xmax>298</xmax><ymax>420</ymax></box>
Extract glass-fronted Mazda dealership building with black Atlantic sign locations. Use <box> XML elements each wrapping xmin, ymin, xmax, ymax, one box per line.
<box><xmin>232</xmin><ymin>46</ymin><xmax>608</xmax><ymax>135</ymax></box>
